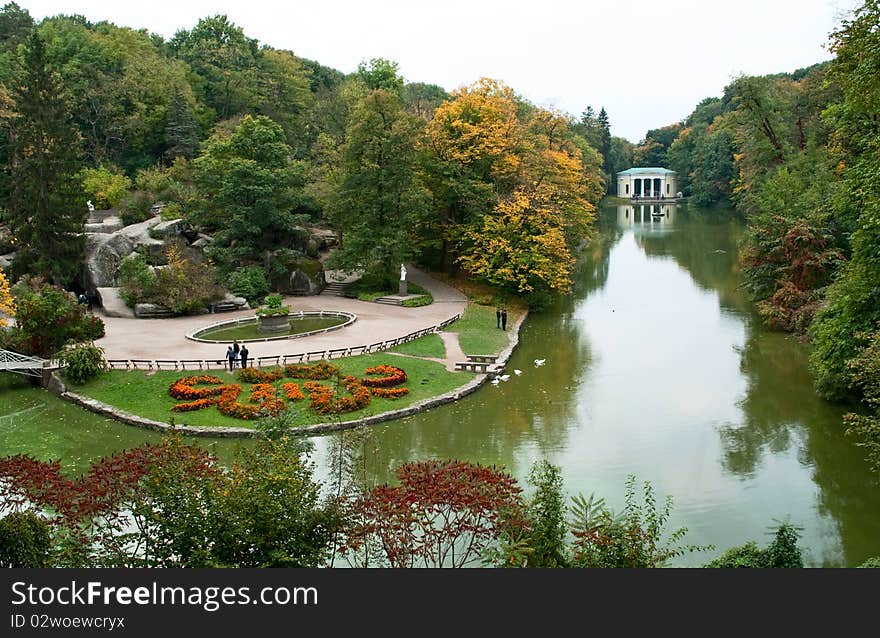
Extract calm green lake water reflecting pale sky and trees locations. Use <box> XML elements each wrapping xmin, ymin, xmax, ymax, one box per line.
<box><xmin>0</xmin><ymin>204</ymin><xmax>880</xmax><ymax>566</ymax></box>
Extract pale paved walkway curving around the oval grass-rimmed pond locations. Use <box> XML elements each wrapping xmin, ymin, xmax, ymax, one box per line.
<box><xmin>96</xmin><ymin>267</ymin><xmax>467</xmax><ymax>369</ymax></box>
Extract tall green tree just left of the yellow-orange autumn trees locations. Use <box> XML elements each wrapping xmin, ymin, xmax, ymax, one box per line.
<box><xmin>328</xmin><ymin>89</ymin><xmax>429</xmax><ymax>287</ymax></box>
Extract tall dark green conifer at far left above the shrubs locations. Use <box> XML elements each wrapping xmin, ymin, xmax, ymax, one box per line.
<box><xmin>7</xmin><ymin>34</ymin><xmax>87</xmax><ymax>285</ymax></box>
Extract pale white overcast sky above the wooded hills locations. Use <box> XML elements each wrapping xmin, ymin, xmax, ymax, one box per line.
<box><xmin>18</xmin><ymin>0</ymin><xmax>860</xmax><ymax>142</ymax></box>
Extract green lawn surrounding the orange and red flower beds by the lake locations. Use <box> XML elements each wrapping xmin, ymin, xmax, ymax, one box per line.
<box><xmin>70</xmin><ymin>353</ymin><xmax>474</xmax><ymax>427</ymax></box>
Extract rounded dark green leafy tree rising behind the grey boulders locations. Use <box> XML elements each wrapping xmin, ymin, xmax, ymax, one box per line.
<box><xmin>192</xmin><ymin>115</ymin><xmax>304</xmax><ymax>269</ymax></box>
